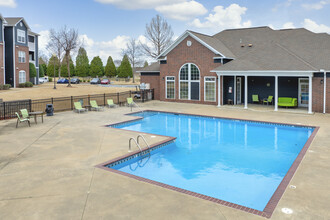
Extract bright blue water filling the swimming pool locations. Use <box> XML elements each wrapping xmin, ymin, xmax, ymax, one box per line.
<box><xmin>111</xmin><ymin>112</ymin><xmax>313</xmax><ymax>211</ymax></box>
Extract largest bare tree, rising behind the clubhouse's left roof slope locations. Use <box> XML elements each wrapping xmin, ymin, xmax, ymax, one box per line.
<box><xmin>141</xmin><ymin>15</ymin><xmax>173</xmax><ymax>58</ymax></box>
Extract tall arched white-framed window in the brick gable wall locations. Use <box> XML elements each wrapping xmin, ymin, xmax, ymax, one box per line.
<box><xmin>179</xmin><ymin>63</ymin><xmax>200</xmax><ymax>100</ymax></box>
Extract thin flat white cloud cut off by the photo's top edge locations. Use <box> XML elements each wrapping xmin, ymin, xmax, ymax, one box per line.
<box><xmin>95</xmin><ymin>0</ymin><xmax>186</xmax><ymax>10</ymax></box>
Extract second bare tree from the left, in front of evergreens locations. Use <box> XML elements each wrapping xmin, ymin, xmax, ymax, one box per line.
<box><xmin>59</xmin><ymin>26</ymin><xmax>80</xmax><ymax>87</ymax></box>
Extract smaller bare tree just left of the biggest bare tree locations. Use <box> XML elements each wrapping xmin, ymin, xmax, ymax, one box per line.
<box><xmin>122</xmin><ymin>38</ymin><xmax>142</xmax><ymax>83</ymax></box>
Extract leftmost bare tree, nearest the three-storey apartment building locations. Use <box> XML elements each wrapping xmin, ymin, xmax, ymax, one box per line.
<box><xmin>47</xmin><ymin>29</ymin><xmax>64</xmax><ymax>77</ymax></box>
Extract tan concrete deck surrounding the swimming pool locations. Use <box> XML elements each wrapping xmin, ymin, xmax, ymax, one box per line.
<box><xmin>0</xmin><ymin>101</ymin><xmax>330</xmax><ymax>219</ymax></box>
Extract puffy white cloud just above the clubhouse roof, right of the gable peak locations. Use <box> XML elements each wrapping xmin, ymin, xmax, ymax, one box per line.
<box><xmin>191</xmin><ymin>4</ymin><xmax>251</xmax><ymax>31</ymax></box>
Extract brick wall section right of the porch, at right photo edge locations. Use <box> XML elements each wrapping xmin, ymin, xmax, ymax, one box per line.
<box><xmin>312</xmin><ymin>77</ymin><xmax>330</xmax><ymax>113</ymax></box>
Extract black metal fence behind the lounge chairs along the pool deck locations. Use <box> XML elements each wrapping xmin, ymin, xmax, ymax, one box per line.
<box><xmin>0</xmin><ymin>89</ymin><xmax>154</xmax><ymax>120</ymax></box>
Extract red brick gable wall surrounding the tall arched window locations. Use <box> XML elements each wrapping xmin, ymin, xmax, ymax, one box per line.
<box><xmin>159</xmin><ymin>36</ymin><xmax>221</xmax><ymax>105</ymax></box>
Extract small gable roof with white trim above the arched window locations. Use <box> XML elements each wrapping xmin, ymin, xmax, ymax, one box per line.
<box><xmin>157</xmin><ymin>30</ymin><xmax>233</xmax><ymax>59</ymax></box>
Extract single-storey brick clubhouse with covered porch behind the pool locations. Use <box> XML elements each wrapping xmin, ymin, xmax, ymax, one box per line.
<box><xmin>140</xmin><ymin>27</ymin><xmax>330</xmax><ymax>113</ymax></box>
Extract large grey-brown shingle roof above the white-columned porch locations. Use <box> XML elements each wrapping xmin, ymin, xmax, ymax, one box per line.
<box><xmin>213</xmin><ymin>27</ymin><xmax>330</xmax><ymax>71</ymax></box>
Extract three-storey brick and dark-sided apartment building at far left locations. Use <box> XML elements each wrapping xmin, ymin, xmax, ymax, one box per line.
<box><xmin>0</xmin><ymin>15</ymin><xmax>39</xmax><ymax>87</ymax></box>
